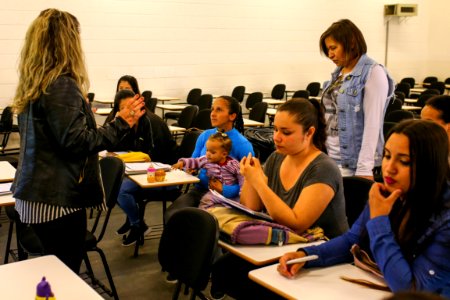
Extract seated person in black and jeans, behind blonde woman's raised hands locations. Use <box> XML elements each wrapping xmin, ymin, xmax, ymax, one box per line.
<box><xmin>107</xmin><ymin>89</ymin><xmax>176</xmax><ymax>246</ymax></box>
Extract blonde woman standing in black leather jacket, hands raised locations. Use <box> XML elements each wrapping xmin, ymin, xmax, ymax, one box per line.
<box><xmin>12</xmin><ymin>9</ymin><xmax>145</xmax><ymax>273</ymax></box>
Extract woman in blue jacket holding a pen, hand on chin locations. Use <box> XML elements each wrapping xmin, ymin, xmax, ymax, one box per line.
<box><xmin>278</xmin><ymin>120</ymin><xmax>450</xmax><ymax>297</ymax></box>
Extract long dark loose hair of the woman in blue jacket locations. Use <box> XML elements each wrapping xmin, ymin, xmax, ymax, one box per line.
<box><xmin>386</xmin><ymin>120</ymin><xmax>449</xmax><ymax>261</ymax></box>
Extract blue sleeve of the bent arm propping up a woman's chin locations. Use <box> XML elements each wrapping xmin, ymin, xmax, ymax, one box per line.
<box><xmin>367</xmin><ymin>216</ymin><xmax>450</xmax><ymax>296</ymax></box>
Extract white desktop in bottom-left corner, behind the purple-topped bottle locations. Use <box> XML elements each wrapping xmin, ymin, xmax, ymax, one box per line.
<box><xmin>0</xmin><ymin>255</ymin><xmax>103</xmax><ymax>300</ymax></box>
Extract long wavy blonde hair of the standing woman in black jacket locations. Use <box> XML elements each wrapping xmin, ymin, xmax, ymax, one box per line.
<box><xmin>13</xmin><ymin>8</ymin><xmax>89</xmax><ymax>113</ymax></box>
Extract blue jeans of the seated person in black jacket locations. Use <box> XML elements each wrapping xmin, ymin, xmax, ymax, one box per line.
<box><xmin>117</xmin><ymin>177</ymin><xmax>177</xmax><ymax>226</ymax></box>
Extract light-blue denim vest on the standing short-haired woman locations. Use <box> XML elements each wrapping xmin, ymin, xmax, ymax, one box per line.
<box><xmin>324</xmin><ymin>54</ymin><xmax>395</xmax><ymax>170</ymax></box>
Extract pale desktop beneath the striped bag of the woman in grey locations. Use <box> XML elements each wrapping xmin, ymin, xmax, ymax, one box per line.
<box><xmin>219</xmin><ymin>240</ymin><xmax>324</xmax><ymax>266</ymax></box>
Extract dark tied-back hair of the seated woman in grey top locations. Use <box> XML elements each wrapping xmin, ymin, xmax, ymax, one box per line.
<box><xmin>277</xmin><ymin>98</ymin><xmax>327</xmax><ymax>153</ymax></box>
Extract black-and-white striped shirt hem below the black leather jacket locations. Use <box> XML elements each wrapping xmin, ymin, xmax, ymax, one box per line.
<box><xmin>16</xmin><ymin>199</ymin><xmax>106</xmax><ymax>224</ymax></box>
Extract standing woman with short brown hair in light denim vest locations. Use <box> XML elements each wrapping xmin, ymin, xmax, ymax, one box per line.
<box><xmin>320</xmin><ymin>20</ymin><xmax>394</xmax><ymax>179</ymax></box>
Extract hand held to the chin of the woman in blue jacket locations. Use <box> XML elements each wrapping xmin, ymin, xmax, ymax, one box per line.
<box><xmin>369</xmin><ymin>183</ymin><xmax>402</xmax><ymax>219</ymax></box>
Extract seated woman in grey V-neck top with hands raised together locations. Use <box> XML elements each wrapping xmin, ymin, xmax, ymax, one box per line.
<box><xmin>211</xmin><ymin>99</ymin><xmax>348</xmax><ymax>299</ymax></box>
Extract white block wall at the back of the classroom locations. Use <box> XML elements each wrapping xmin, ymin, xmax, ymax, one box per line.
<box><xmin>0</xmin><ymin>0</ymin><xmax>450</xmax><ymax>106</ymax></box>
